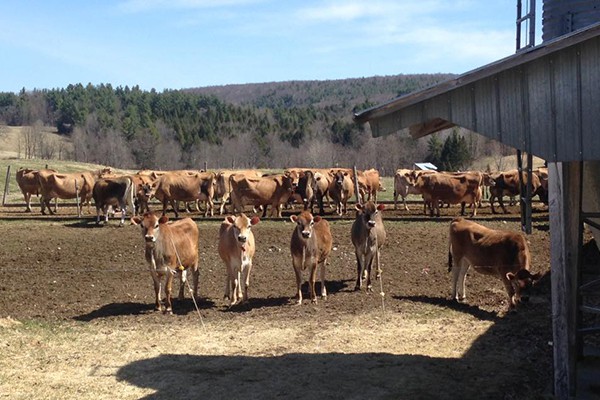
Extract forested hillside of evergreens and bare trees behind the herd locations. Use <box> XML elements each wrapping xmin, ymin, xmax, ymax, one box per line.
<box><xmin>0</xmin><ymin>74</ymin><xmax>510</xmax><ymax>171</ymax></box>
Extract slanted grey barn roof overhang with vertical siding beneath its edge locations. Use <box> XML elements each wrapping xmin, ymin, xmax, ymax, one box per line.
<box><xmin>354</xmin><ymin>23</ymin><xmax>600</xmax><ymax>161</ymax></box>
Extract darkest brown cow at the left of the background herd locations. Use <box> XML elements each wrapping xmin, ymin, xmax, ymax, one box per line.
<box><xmin>92</xmin><ymin>176</ymin><xmax>135</xmax><ymax>225</ymax></box>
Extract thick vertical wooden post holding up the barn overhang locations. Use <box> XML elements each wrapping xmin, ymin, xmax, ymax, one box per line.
<box><xmin>548</xmin><ymin>162</ymin><xmax>582</xmax><ymax>399</ymax></box>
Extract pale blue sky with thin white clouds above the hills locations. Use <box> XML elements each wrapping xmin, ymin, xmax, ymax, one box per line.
<box><xmin>0</xmin><ymin>0</ymin><xmax>541</xmax><ymax>92</ymax></box>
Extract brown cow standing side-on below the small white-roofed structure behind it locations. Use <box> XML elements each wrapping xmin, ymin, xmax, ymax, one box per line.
<box><xmin>415</xmin><ymin>172</ymin><xmax>483</xmax><ymax>217</ymax></box>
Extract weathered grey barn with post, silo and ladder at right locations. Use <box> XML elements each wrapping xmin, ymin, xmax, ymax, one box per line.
<box><xmin>355</xmin><ymin>0</ymin><xmax>600</xmax><ymax>399</ymax></box>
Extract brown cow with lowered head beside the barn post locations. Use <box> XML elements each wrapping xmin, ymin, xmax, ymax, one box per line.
<box><xmin>448</xmin><ymin>218</ymin><xmax>541</xmax><ymax>309</ymax></box>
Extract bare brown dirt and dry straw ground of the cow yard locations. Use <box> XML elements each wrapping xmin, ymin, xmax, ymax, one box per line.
<box><xmin>0</xmin><ymin>208</ymin><xmax>552</xmax><ymax>400</ymax></box>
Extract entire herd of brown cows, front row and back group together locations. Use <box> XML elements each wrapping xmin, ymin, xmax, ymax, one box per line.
<box><xmin>11</xmin><ymin>168</ymin><xmax>547</xmax><ymax>313</ymax></box>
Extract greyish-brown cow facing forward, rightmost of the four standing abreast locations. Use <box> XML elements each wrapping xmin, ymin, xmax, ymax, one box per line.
<box><xmin>351</xmin><ymin>201</ymin><xmax>386</xmax><ymax>291</ymax></box>
